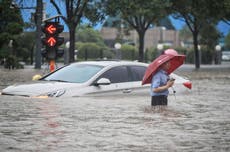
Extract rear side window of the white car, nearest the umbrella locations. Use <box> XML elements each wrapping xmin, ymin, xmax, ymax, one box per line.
<box><xmin>129</xmin><ymin>66</ymin><xmax>146</xmax><ymax>81</ymax></box>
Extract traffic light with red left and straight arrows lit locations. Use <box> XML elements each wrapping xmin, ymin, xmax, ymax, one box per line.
<box><xmin>41</xmin><ymin>22</ymin><xmax>64</xmax><ymax>60</ymax></box>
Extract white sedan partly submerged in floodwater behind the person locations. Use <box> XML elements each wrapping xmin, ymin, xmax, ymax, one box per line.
<box><xmin>2</xmin><ymin>61</ymin><xmax>191</xmax><ymax>97</ymax></box>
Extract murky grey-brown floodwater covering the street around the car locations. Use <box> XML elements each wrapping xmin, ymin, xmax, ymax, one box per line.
<box><xmin>0</xmin><ymin>64</ymin><xmax>230</xmax><ymax>152</ymax></box>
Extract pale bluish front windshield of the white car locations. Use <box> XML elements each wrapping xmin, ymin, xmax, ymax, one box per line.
<box><xmin>42</xmin><ymin>64</ymin><xmax>103</xmax><ymax>83</ymax></box>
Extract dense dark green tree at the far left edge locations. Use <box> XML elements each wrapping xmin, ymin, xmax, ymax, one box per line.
<box><xmin>0</xmin><ymin>0</ymin><xmax>23</xmax><ymax>68</ymax></box>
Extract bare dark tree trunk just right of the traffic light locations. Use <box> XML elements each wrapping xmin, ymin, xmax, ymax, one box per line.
<box><xmin>69</xmin><ymin>28</ymin><xmax>75</xmax><ymax>63</ymax></box>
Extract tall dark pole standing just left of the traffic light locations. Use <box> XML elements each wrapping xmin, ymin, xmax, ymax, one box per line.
<box><xmin>35</xmin><ymin>0</ymin><xmax>43</xmax><ymax>69</ymax></box>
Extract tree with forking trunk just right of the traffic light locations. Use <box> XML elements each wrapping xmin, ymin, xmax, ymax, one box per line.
<box><xmin>50</xmin><ymin>0</ymin><xmax>103</xmax><ymax>62</ymax></box>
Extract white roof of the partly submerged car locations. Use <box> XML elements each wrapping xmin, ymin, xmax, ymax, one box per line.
<box><xmin>72</xmin><ymin>60</ymin><xmax>148</xmax><ymax>67</ymax></box>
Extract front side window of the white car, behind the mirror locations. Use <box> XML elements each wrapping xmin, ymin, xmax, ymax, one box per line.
<box><xmin>99</xmin><ymin>66</ymin><xmax>129</xmax><ymax>83</ymax></box>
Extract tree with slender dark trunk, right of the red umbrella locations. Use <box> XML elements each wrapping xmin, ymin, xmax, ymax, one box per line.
<box><xmin>171</xmin><ymin>0</ymin><xmax>223</xmax><ymax>69</ymax></box>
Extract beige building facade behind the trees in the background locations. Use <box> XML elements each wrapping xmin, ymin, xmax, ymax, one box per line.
<box><xmin>100</xmin><ymin>27</ymin><xmax>180</xmax><ymax>49</ymax></box>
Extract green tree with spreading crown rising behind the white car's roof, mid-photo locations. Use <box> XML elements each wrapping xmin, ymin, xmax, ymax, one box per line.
<box><xmin>104</xmin><ymin>0</ymin><xmax>170</xmax><ymax>61</ymax></box>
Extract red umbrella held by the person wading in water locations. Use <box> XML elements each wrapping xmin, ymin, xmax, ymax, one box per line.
<box><xmin>142</xmin><ymin>49</ymin><xmax>185</xmax><ymax>85</ymax></box>
